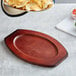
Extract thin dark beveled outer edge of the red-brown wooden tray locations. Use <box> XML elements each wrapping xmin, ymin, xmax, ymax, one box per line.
<box><xmin>4</xmin><ymin>29</ymin><xmax>68</xmax><ymax>67</ymax></box>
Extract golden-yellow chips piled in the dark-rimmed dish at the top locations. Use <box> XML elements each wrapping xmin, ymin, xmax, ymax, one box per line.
<box><xmin>4</xmin><ymin>0</ymin><xmax>53</xmax><ymax>11</ymax></box>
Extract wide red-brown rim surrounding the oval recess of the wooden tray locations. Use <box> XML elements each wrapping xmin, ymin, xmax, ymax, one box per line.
<box><xmin>4</xmin><ymin>29</ymin><xmax>68</xmax><ymax>67</ymax></box>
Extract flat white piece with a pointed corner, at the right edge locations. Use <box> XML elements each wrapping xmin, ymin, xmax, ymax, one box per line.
<box><xmin>56</xmin><ymin>16</ymin><xmax>76</xmax><ymax>36</ymax></box>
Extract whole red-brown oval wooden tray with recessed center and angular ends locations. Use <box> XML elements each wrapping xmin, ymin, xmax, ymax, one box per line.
<box><xmin>5</xmin><ymin>29</ymin><xmax>68</xmax><ymax>67</ymax></box>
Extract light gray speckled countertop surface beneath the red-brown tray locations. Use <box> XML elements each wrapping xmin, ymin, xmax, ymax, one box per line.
<box><xmin>0</xmin><ymin>4</ymin><xmax>76</xmax><ymax>76</ymax></box>
